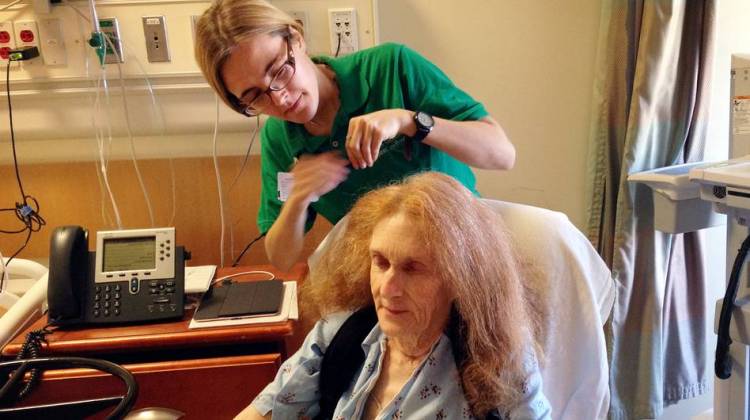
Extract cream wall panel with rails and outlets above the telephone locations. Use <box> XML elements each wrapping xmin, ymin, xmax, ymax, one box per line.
<box><xmin>0</xmin><ymin>0</ymin><xmax>375</xmax><ymax>164</ymax></box>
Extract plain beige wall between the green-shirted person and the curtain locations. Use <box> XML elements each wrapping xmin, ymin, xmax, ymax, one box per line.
<box><xmin>378</xmin><ymin>0</ymin><xmax>601</xmax><ymax>228</ymax></box>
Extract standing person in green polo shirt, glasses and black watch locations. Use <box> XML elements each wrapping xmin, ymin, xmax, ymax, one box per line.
<box><xmin>195</xmin><ymin>0</ymin><xmax>515</xmax><ymax>269</ymax></box>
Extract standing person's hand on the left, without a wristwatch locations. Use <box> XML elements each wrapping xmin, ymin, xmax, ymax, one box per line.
<box><xmin>289</xmin><ymin>151</ymin><xmax>349</xmax><ymax>204</ymax></box>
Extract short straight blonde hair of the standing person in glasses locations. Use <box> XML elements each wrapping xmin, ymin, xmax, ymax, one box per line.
<box><xmin>195</xmin><ymin>0</ymin><xmax>304</xmax><ymax>115</ymax></box>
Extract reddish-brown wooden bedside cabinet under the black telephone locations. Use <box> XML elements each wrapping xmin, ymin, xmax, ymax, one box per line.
<box><xmin>2</xmin><ymin>264</ymin><xmax>306</xmax><ymax>419</ymax></box>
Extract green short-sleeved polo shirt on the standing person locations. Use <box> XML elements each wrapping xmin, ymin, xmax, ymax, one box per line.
<box><xmin>258</xmin><ymin>43</ymin><xmax>488</xmax><ymax>232</ymax></box>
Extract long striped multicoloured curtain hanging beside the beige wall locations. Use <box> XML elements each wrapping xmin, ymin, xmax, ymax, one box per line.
<box><xmin>588</xmin><ymin>0</ymin><xmax>715</xmax><ymax>419</ymax></box>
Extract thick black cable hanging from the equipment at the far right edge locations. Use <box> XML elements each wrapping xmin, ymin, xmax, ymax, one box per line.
<box><xmin>714</xmin><ymin>235</ymin><xmax>750</xmax><ymax>379</ymax></box>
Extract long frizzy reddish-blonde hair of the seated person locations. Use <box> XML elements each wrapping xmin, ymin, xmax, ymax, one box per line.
<box><xmin>301</xmin><ymin>172</ymin><xmax>541</xmax><ymax>418</ymax></box>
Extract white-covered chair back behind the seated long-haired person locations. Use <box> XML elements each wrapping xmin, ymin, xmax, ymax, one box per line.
<box><xmin>308</xmin><ymin>199</ymin><xmax>615</xmax><ymax>420</ymax></box>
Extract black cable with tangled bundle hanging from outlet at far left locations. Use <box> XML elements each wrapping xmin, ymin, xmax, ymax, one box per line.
<box><xmin>0</xmin><ymin>60</ymin><xmax>46</xmax><ymax>278</ymax></box>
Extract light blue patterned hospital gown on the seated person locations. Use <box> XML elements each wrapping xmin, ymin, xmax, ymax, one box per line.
<box><xmin>253</xmin><ymin>313</ymin><xmax>550</xmax><ymax>420</ymax></box>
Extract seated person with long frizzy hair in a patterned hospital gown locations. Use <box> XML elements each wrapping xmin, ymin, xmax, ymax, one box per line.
<box><xmin>238</xmin><ymin>173</ymin><xmax>550</xmax><ymax>419</ymax></box>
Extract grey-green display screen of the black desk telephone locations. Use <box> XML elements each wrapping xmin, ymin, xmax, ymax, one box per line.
<box><xmin>102</xmin><ymin>236</ymin><xmax>156</xmax><ymax>272</ymax></box>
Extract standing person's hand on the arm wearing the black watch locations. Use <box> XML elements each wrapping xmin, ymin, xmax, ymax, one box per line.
<box><xmin>346</xmin><ymin>109</ymin><xmax>414</xmax><ymax>169</ymax></box>
